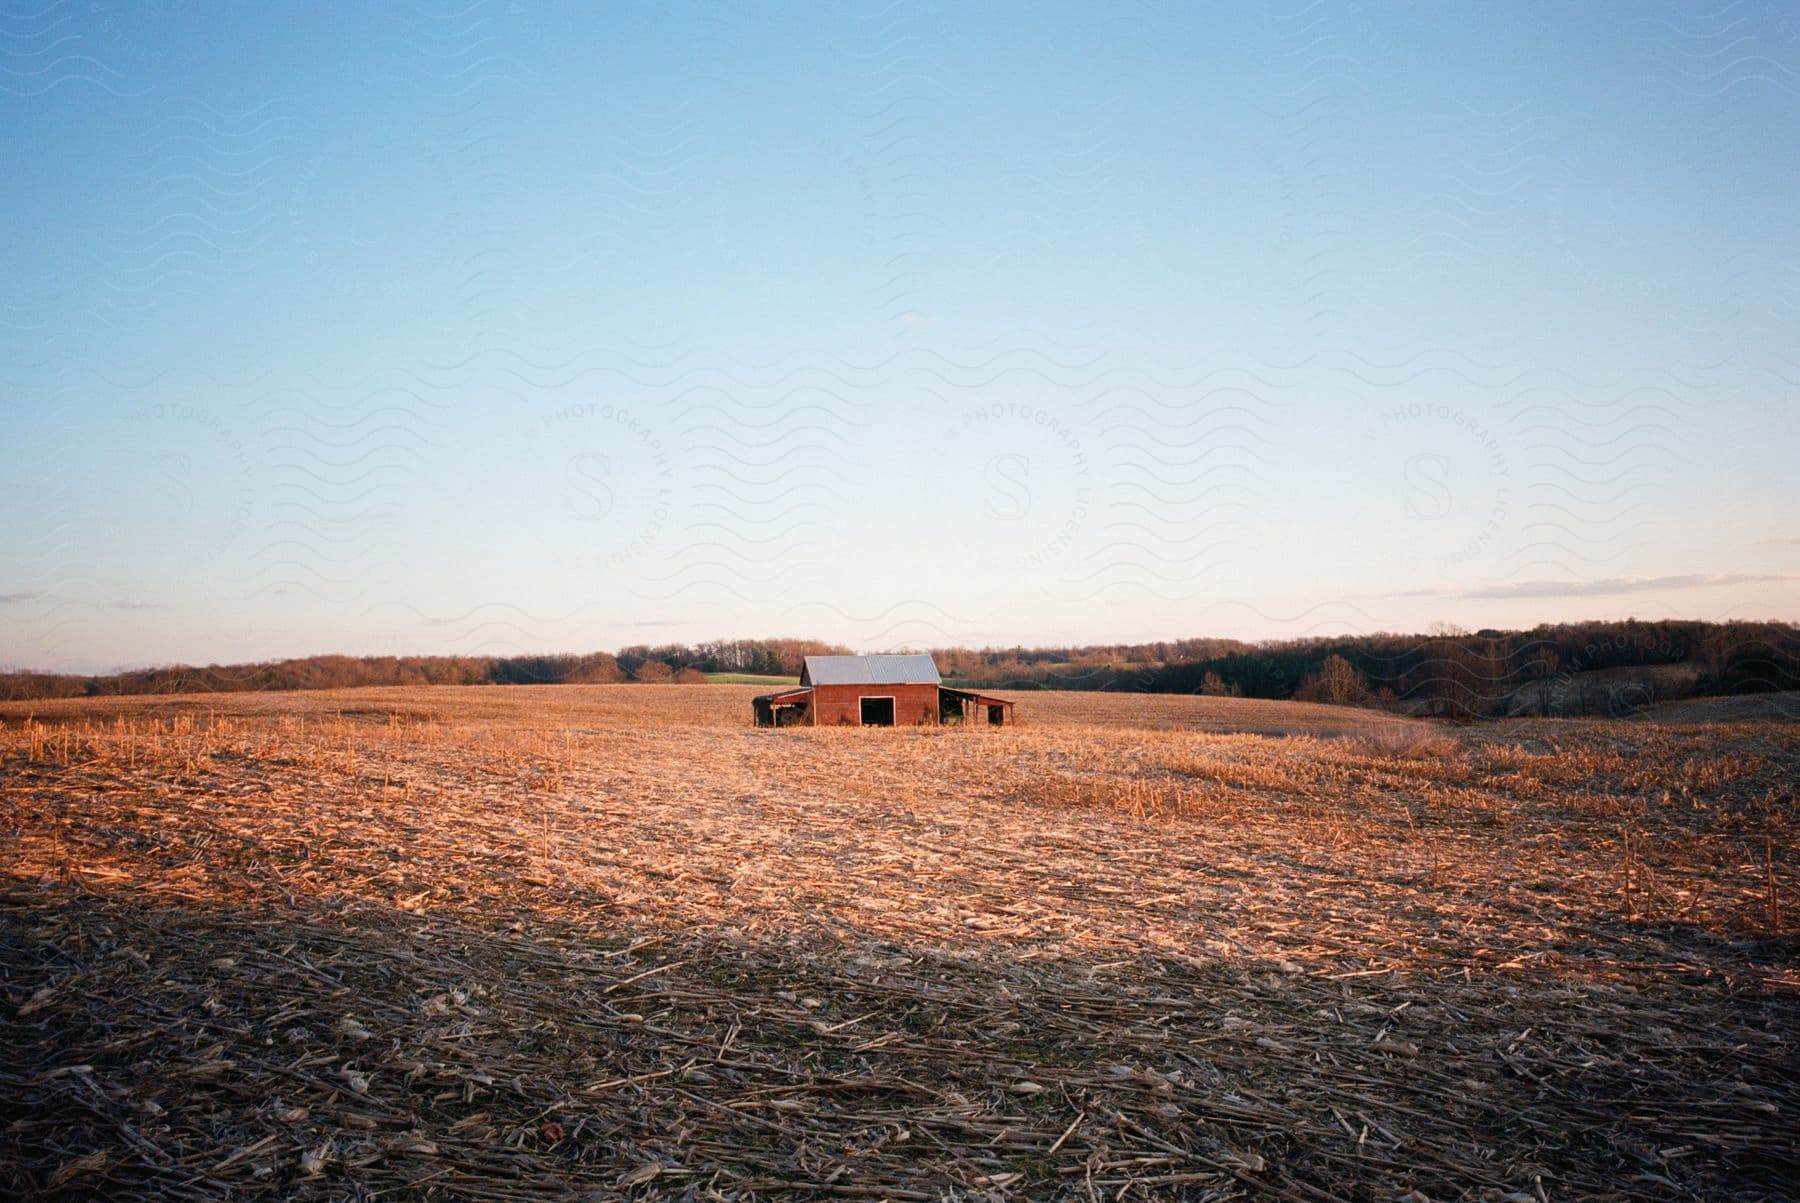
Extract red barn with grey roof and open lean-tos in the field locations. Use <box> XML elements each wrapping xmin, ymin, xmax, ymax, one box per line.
<box><xmin>754</xmin><ymin>656</ymin><xmax>1012</xmax><ymax>728</ymax></box>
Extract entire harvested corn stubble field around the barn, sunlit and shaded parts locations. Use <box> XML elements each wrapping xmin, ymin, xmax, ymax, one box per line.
<box><xmin>0</xmin><ymin>686</ymin><xmax>1800</xmax><ymax>1201</ymax></box>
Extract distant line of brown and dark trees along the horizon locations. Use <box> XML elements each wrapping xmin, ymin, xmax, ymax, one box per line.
<box><xmin>0</xmin><ymin>620</ymin><xmax>1800</xmax><ymax>719</ymax></box>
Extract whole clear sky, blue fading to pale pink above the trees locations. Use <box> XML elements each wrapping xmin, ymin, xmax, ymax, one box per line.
<box><xmin>0</xmin><ymin>0</ymin><xmax>1800</xmax><ymax>672</ymax></box>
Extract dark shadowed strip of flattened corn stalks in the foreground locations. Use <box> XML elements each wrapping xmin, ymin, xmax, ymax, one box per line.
<box><xmin>10</xmin><ymin>881</ymin><xmax>1800</xmax><ymax>1199</ymax></box>
